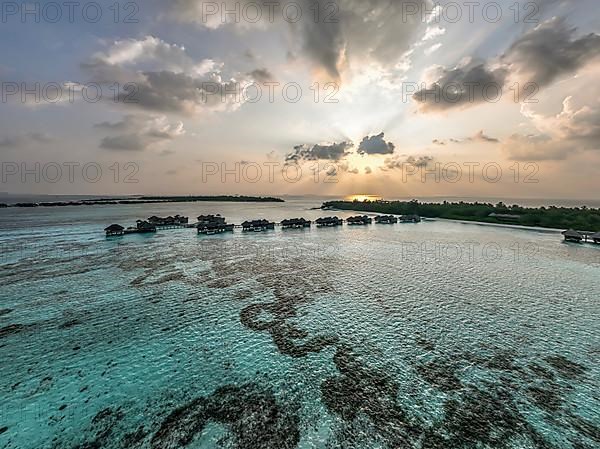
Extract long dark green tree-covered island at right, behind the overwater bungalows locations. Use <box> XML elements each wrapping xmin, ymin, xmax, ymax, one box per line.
<box><xmin>322</xmin><ymin>200</ymin><xmax>600</xmax><ymax>231</ymax></box>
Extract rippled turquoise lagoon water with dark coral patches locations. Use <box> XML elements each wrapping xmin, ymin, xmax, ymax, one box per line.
<box><xmin>0</xmin><ymin>200</ymin><xmax>600</xmax><ymax>449</ymax></box>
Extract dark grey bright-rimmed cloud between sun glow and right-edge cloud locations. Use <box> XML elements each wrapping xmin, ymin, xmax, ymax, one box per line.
<box><xmin>413</xmin><ymin>59</ymin><xmax>507</xmax><ymax>112</ymax></box>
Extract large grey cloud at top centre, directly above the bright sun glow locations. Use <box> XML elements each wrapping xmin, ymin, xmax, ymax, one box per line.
<box><xmin>172</xmin><ymin>0</ymin><xmax>437</xmax><ymax>80</ymax></box>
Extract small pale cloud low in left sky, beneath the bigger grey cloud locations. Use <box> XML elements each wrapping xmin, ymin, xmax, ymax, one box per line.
<box><xmin>94</xmin><ymin>115</ymin><xmax>185</xmax><ymax>154</ymax></box>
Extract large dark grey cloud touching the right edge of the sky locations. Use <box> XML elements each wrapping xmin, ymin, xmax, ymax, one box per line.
<box><xmin>501</xmin><ymin>17</ymin><xmax>600</xmax><ymax>87</ymax></box>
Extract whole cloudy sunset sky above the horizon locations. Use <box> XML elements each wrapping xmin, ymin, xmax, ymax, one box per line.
<box><xmin>0</xmin><ymin>0</ymin><xmax>600</xmax><ymax>199</ymax></box>
